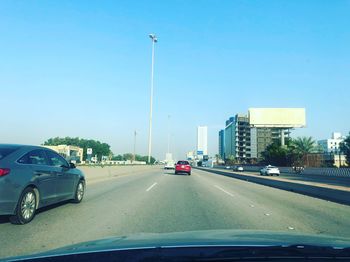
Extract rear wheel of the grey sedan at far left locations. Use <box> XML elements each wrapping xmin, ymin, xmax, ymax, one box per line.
<box><xmin>10</xmin><ymin>187</ymin><xmax>37</xmax><ymax>225</ymax></box>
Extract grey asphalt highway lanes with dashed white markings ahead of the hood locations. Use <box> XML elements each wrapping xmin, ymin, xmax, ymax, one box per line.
<box><xmin>0</xmin><ymin>167</ymin><xmax>350</xmax><ymax>258</ymax></box>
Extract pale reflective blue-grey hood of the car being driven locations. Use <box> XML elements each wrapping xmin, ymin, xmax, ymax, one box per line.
<box><xmin>6</xmin><ymin>230</ymin><xmax>350</xmax><ymax>261</ymax></box>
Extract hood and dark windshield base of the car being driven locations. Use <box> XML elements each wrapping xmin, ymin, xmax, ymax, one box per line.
<box><xmin>6</xmin><ymin>230</ymin><xmax>350</xmax><ymax>262</ymax></box>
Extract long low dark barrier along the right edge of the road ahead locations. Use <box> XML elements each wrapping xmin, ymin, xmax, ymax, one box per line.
<box><xmin>196</xmin><ymin>167</ymin><xmax>350</xmax><ymax>205</ymax></box>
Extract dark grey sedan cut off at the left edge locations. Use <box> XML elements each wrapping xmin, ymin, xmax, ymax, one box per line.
<box><xmin>0</xmin><ymin>144</ymin><xmax>85</xmax><ymax>224</ymax></box>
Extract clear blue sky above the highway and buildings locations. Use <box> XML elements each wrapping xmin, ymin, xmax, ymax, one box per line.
<box><xmin>0</xmin><ymin>0</ymin><xmax>350</xmax><ymax>158</ymax></box>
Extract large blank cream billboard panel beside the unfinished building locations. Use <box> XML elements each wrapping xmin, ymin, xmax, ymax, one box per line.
<box><xmin>248</xmin><ymin>108</ymin><xmax>306</xmax><ymax>128</ymax></box>
